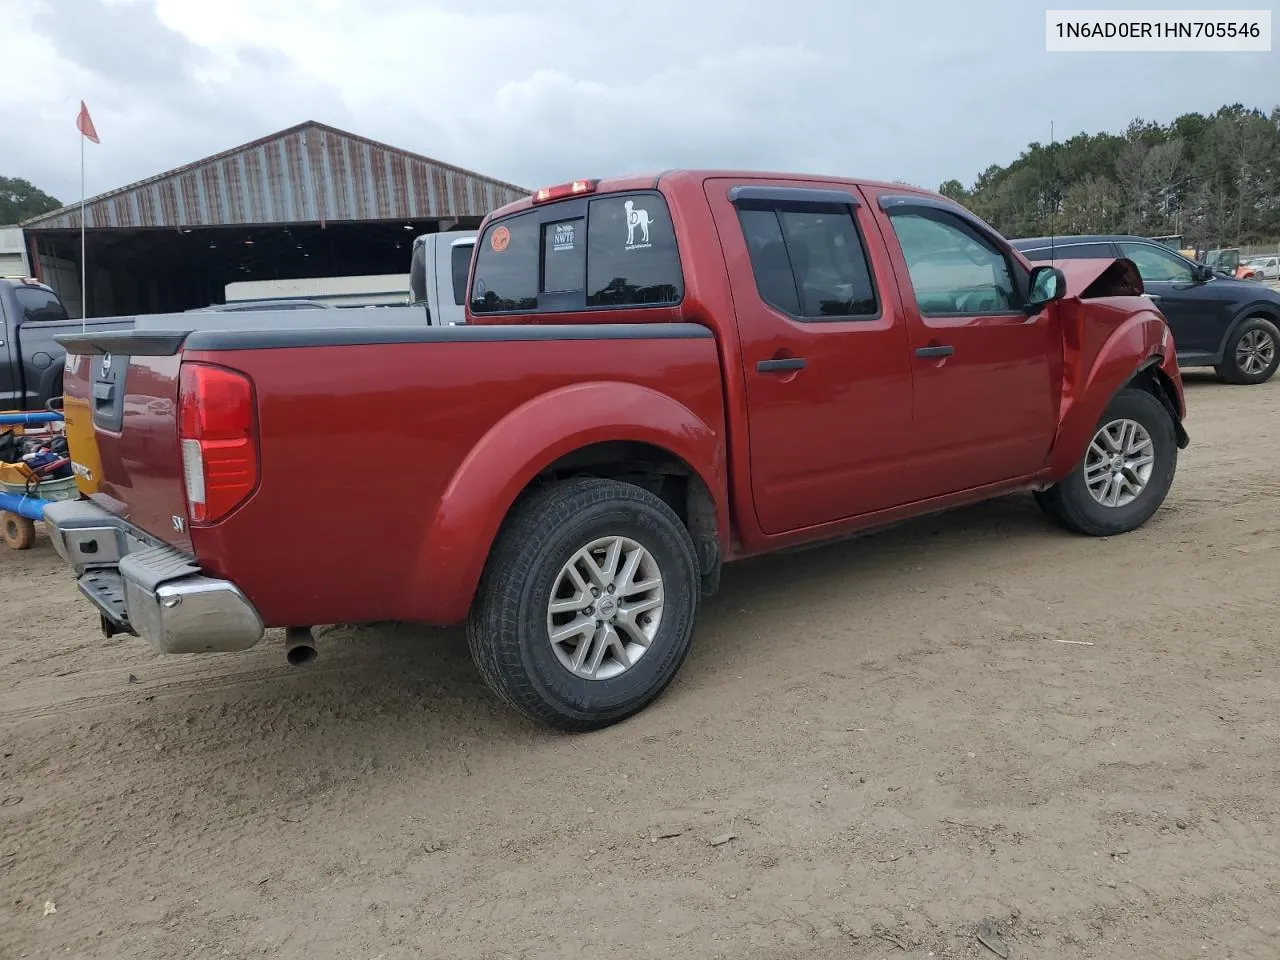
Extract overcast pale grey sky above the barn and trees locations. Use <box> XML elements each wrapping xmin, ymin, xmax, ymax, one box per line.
<box><xmin>0</xmin><ymin>0</ymin><xmax>1280</xmax><ymax>202</ymax></box>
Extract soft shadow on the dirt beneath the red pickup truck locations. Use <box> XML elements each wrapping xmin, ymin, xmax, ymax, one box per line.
<box><xmin>24</xmin><ymin>488</ymin><xmax>1167</xmax><ymax>817</ymax></box>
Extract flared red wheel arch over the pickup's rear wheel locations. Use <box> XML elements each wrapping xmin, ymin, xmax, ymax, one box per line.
<box><xmin>406</xmin><ymin>381</ymin><xmax>728</xmax><ymax>623</ymax></box>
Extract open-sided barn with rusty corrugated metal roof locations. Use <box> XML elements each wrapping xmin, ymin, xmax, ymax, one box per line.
<box><xmin>23</xmin><ymin>120</ymin><xmax>529</xmax><ymax>316</ymax></box>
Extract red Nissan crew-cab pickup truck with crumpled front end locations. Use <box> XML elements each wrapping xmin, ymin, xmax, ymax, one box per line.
<box><xmin>47</xmin><ymin>172</ymin><xmax>1187</xmax><ymax>730</ymax></box>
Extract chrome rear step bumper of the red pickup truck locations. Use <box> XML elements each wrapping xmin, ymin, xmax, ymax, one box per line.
<box><xmin>45</xmin><ymin>500</ymin><xmax>262</xmax><ymax>653</ymax></box>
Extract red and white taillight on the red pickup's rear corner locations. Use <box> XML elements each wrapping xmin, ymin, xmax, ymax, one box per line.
<box><xmin>178</xmin><ymin>364</ymin><xmax>257</xmax><ymax>524</ymax></box>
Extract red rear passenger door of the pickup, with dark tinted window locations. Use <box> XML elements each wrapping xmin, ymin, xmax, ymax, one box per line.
<box><xmin>705</xmin><ymin>178</ymin><xmax>911</xmax><ymax>534</ymax></box>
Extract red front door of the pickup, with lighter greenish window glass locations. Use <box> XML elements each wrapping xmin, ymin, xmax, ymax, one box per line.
<box><xmin>877</xmin><ymin>196</ymin><xmax>1062</xmax><ymax>500</ymax></box>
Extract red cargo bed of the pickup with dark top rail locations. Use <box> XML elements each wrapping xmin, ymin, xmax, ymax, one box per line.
<box><xmin>61</xmin><ymin>320</ymin><xmax>723</xmax><ymax>625</ymax></box>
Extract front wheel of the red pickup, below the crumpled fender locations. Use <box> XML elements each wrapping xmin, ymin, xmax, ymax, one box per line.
<box><xmin>1036</xmin><ymin>389</ymin><xmax>1178</xmax><ymax>536</ymax></box>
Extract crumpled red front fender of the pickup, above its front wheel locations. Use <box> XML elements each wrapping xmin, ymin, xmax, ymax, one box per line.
<box><xmin>1044</xmin><ymin>297</ymin><xmax>1174</xmax><ymax>483</ymax></box>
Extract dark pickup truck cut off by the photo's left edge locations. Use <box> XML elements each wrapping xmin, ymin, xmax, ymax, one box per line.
<box><xmin>0</xmin><ymin>276</ymin><xmax>133</xmax><ymax>410</ymax></box>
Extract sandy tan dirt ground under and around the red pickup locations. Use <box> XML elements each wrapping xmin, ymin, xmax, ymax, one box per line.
<box><xmin>0</xmin><ymin>374</ymin><xmax>1280</xmax><ymax>960</ymax></box>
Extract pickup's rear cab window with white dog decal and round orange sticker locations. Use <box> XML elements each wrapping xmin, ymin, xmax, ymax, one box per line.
<box><xmin>471</xmin><ymin>192</ymin><xmax>685</xmax><ymax>314</ymax></box>
